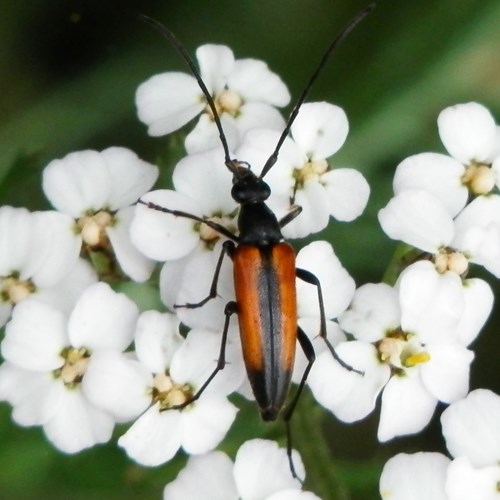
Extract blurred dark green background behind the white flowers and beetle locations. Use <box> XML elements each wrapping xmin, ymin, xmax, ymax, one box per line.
<box><xmin>0</xmin><ymin>0</ymin><xmax>500</xmax><ymax>500</ymax></box>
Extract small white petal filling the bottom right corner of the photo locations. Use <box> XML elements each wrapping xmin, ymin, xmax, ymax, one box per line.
<box><xmin>446</xmin><ymin>457</ymin><xmax>500</xmax><ymax>500</ymax></box>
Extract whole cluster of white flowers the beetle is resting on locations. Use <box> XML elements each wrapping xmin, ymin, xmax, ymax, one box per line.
<box><xmin>0</xmin><ymin>29</ymin><xmax>500</xmax><ymax>500</ymax></box>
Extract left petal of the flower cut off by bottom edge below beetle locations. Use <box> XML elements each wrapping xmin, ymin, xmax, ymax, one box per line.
<box><xmin>163</xmin><ymin>451</ymin><xmax>238</xmax><ymax>500</ymax></box>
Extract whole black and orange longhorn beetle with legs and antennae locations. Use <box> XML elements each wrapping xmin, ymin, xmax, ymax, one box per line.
<box><xmin>138</xmin><ymin>4</ymin><xmax>375</xmax><ymax>480</ymax></box>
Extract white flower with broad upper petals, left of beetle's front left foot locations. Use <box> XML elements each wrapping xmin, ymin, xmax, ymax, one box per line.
<box><xmin>43</xmin><ymin>147</ymin><xmax>158</xmax><ymax>281</ymax></box>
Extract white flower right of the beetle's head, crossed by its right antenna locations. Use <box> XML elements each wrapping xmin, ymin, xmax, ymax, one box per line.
<box><xmin>237</xmin><ymin>102</ymin><xmax>370</xmax><ymax>238</ymax></box>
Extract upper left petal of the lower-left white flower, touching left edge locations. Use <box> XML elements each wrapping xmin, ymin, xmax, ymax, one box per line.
<box><xmin>2</xmin><ymin>299</ymin><xmax>68</xmax><ymax>371</ymax></box>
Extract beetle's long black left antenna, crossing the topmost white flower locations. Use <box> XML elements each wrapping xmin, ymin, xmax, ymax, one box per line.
<box><xmin>139</xmin><ymin>14</ymin><xmax>235</xmax><ymax>173</ymax></box>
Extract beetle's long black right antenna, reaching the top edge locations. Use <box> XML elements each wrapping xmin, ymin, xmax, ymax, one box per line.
<box><xmin>259</xmin><ymin>3</ymin><xmax>375</xmax><ymax>179</ymax></box>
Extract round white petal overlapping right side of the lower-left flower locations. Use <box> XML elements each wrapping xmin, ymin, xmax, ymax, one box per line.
<box><xmin>82</xmin><ymin>351</ymin><xmax>153</xmax><ymax>422</ymax></box>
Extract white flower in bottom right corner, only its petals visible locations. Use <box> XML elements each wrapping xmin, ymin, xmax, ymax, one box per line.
<box><xmin>380</xmin><ymin>389</ymin><xmax>500</xmax><ymax>500</ymax></box>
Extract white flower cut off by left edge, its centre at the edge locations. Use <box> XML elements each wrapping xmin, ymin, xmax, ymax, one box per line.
<box><xmin>0</xmin><ymin>206</ymin><xmax>96</xmax><ymax>326</ymax></box>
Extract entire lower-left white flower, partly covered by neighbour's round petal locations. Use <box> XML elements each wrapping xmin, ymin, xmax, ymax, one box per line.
<box><xmin>0</xmin><ymin>283</ymin><xmax>138</xmax><ymax>453</ymax></box>
